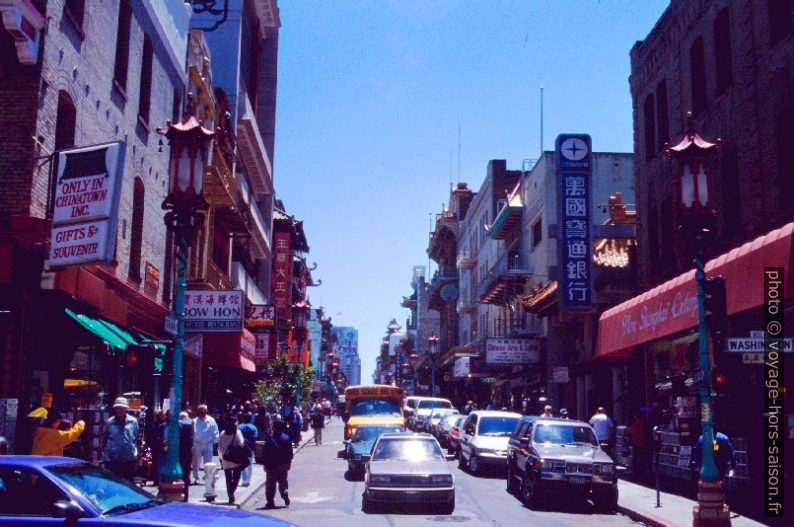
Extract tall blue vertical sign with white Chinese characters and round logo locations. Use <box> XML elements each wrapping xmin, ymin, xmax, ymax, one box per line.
<box><xmin>555</xmin><ymin>134</ymin><xmax>593</xmax><ymax>310</ymax></box>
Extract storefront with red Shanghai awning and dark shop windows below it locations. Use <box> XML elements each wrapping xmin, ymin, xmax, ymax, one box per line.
<box><xmin>595</xmin><ymin>224</ymin><xmax>794</xmax><ymax>487</ymax></box>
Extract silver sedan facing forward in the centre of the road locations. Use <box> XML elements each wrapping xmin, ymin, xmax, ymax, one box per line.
<box><xmin>361</xmin><ymin>432</ymin><xmax>455</xmax><ymax>514</ymax></box>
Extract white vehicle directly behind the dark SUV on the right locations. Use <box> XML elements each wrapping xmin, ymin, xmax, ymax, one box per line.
<box><xmin>458</xmin><ymin>410</ymin><xmax>521</xmax><ymax>475</ymax></box>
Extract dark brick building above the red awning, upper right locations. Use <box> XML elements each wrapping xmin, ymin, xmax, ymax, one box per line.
<box><xmin>629</xmin><ymin>0</ymin><xmax>794</xmax><ymax>287</ymax></box>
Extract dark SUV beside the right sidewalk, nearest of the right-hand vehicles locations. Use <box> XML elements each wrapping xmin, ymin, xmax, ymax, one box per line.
<box><xmin>507</xmin><ymin>416</ymin><xmax>618</xmax><ymax>512</ymax></box>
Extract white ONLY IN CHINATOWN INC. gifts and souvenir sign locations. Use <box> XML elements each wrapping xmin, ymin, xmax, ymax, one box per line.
<box><xmin>49</xmin><ymin>141</ymin><xmax>126</xmax><ymax>268</ymax></box>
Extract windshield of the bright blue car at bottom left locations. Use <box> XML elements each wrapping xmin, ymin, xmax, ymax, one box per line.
<box><xmin>47</xmin><ymin>463</ymin><xmax>162</xmax><ymax>515</ymax></box>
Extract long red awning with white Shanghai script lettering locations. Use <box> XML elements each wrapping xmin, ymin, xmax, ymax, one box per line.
<box><xmin>595</xmin><ymin>223</ymin><xmax>794</xmax><ymax>358</ymax></box>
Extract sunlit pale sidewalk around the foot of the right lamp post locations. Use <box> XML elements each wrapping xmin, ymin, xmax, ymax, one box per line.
<box><xmin>618</xmin><ymin>479</ymin><xmax>764</xmax><ymax>527</ymax></box>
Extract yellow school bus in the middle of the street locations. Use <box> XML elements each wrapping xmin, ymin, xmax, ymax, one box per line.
<box><xmin>342</xmin><ymin>384</ymin><xmax>405</xmax><ymax>439</ymax></box>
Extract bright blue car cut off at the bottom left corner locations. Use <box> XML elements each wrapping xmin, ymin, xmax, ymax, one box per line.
<box><xmin>0</xmin><ymin>456</ymin><xmax>293</xmax><ymax>527</ymax></box>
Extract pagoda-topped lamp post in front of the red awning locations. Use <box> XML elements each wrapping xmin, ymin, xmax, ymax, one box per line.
<box><xmin>665</xmin><ymin>112</ymin><xmax>731</xmax><ymax>527</ymax></box>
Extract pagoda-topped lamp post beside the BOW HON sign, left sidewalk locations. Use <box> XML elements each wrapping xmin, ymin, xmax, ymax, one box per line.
<box><xmin>157</xmin><ymin>93</ymin><xmax>215</xmax><ymax>501</ymax></box>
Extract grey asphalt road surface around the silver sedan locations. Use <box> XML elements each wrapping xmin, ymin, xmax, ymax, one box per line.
<box><xmin>243</xmin><ymin>418</ymin><xmax>638</xmax><ymax>527</ymax></box>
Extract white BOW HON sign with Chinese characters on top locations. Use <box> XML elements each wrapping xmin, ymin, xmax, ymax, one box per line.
<box><xmin>184</xmin><ymin>290</ymin><xmax>244</xmax><ymax>333</ymax></box>
